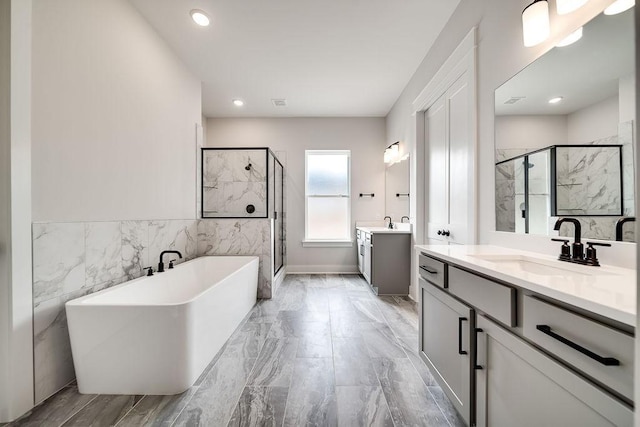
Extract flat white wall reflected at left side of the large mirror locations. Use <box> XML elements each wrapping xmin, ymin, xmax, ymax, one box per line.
<box><xmin>495</xmin><ymin>115</ymin><xmax>567</xmax><ymax>149</ymax></box>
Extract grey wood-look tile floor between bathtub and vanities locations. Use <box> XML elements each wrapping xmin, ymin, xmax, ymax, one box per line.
<box><xmin>9</xmin><ymin>275</ymin><xmax>463</xmax><ymax>427</ymax></box>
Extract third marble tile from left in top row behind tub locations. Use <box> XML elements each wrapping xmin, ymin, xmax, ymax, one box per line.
<box><xmin>120</xmin><ymin>221</ymin><xmax>151</xmax><ymax>280</ymax></box>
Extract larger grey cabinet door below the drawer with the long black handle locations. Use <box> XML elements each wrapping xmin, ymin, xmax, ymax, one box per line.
<box><xmin>475</xmin><ymin>316</ymin><xmax>633</xmax><ymax>427</ymax></box>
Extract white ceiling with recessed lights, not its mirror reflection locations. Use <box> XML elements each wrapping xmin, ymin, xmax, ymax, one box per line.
<box><xmin>130</xmin><ymin>0</ymin><xmax>459</xmax><ymax>117</ymax></box>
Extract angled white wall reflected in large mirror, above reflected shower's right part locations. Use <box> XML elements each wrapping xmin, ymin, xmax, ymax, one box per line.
<box><xmin>567</xmin><ymin>95</ymin><xmax>620</xmax><ymax>144</ymax></box>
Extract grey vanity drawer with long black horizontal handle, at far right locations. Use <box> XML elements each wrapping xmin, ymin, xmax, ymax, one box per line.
<box><xmin>523</xmin><ymin>296</ymin><xmax>634</xmax><ymax>400</ymax></box>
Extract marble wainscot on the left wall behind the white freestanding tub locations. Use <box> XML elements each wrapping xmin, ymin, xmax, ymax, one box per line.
<box><xmin>32</xmin><ymin>220</ymin><xmax>197</xmax><ymax>402</ymax></box>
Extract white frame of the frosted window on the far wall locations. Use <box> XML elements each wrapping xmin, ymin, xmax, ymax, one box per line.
<box><xmin>302</xmin><ymin>150</ymin><xmax>353</xmax><ymax>247</ymax></box>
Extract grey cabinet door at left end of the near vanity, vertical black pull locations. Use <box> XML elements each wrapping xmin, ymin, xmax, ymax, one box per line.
<box><xmin>420</xmin><ymin>279</ymin><xmax>474</xmax><ymax>425</ymax></box>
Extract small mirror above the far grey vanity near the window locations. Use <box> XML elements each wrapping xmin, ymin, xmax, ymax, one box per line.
<box><xmin>384</xmin><ymin>154</ymin><xmax>410</xmax><ymax>222</ymax></box>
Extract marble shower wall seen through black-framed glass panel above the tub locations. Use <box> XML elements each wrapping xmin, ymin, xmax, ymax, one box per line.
<box><xmin>203</xmin><ymin>150</ymin><xmax>272</xmax><ymax>217</ymax></box>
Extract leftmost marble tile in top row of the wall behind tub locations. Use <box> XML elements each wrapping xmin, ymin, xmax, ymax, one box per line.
<box><xmin>33</xmin><ymin>223</ymin><xmax>85</xmax><ymax>304</ymax></box>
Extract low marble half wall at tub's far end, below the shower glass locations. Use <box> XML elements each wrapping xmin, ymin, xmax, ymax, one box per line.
<box><xmin>198</xmin><ymin>218</ymin><xmax>275</xmax><ymax>298</ymax></box>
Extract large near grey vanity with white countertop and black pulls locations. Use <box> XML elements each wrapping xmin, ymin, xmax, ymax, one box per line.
<box><xmin>417</xmin><ymin>246</ymin><xmax>635</xmax><ymax>427</ymax></box>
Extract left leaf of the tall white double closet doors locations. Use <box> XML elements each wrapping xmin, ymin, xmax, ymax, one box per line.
<box><xmin>425</xmin><ymin>95</ymin><xmax>449</xmax><ymax>244</ymax></box>
